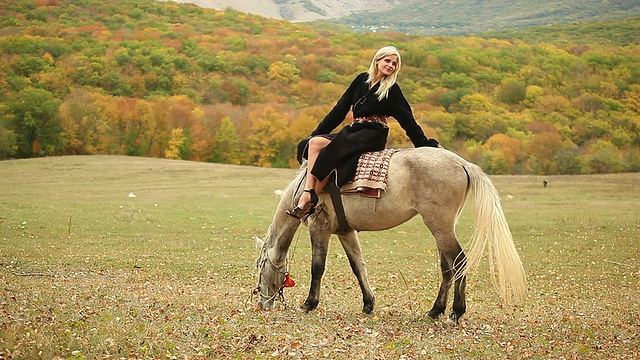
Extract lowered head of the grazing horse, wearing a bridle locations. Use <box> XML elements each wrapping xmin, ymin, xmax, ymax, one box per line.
<box><xmin>253</xmin><ymin>236</ymin><xmax>290</xmax><ymax>310</ymax></box>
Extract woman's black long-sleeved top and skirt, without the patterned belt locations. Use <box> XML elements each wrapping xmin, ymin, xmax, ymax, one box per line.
<box><xmin>298</xmin><ymin>73</ymin><xmax>438</xmax><ymax>186</ymax></box>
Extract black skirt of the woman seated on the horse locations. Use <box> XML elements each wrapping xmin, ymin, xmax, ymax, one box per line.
<box><xmin>298</xmin><ymin>122</ymin><xmax>389</xmax><ymax>187</ymax></box>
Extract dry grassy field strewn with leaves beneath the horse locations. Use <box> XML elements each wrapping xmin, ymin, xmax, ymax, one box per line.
<box><xmin>0</xmin><ymin>156</ymin><xmax>640</xmax><ymax>359</ymax></box>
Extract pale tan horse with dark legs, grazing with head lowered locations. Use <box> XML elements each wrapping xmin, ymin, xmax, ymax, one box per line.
<box><xmin>254</xmin><ymin>147</ymin><xmax>526</xmax><ymax>324</ymax></box>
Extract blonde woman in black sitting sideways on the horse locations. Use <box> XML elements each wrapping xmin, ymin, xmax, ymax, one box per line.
<box><xmin>287</xmin><ymin>46</ymin><xmax>439</xmax><ymax>219</ymax></box>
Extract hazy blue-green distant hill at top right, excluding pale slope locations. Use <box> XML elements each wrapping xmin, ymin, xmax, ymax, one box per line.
<box><xmin>334</xmin><ymin>0</ymin><xmax>640</xmax><ymax>36</ymax></box>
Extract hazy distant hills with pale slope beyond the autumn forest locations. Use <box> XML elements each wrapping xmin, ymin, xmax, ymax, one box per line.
<box><xmin>175</xmin><ymin>0</ymin><xmax>640</xmax><ymax>36</ymax></box>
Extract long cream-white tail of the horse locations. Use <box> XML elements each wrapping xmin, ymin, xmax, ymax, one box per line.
<box><xmin>463</xmin><ymin>163</ymin><xmax>527</xmax><ymax>303</ymax></box>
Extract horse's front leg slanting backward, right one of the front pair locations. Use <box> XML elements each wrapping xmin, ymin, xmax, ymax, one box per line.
<box><xmin>338</xmin><ymin>231</ymin><xmax>376</xmax><ymax>314</ymax></box>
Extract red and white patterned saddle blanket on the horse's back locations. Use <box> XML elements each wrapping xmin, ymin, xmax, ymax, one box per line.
<box><xmin>340</xmin><ymin>149</ymin><xmax>398</xmax><ymax>198</ymax></box>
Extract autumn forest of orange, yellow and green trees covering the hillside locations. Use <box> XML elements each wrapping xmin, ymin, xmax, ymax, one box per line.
<box><xmin>0</xmin><ymin>0</ymin><xmax>640</xmax><ymax>174</ymax></box>
